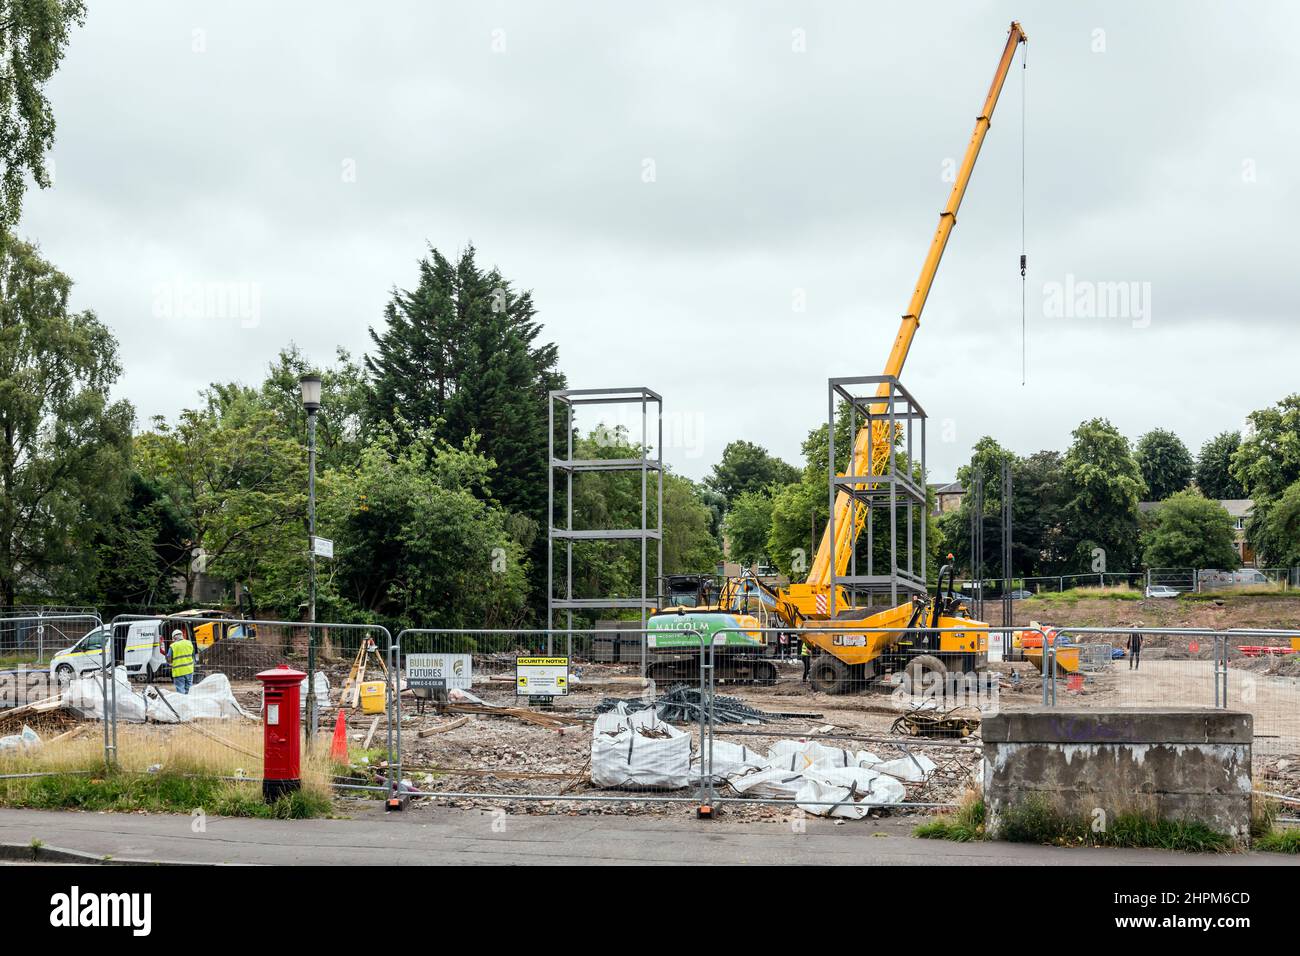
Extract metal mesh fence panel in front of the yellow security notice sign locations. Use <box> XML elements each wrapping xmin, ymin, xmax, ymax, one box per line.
<box><xmin>397</xmin><ymin>627</ymin><xmax>706</xmax><ymax>813</ymax></box>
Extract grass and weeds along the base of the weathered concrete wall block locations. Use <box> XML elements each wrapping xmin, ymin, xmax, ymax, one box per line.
<box><xmin>913</xmin><ymin>800</ymin><xmax>1235</xmax><ymax>853</ymax></box>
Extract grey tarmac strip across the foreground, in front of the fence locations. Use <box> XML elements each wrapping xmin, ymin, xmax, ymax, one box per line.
<box><xmin>0</xmin><ymin>805</ymin><xmax>1300</xmax><ymax>866</ymax></box>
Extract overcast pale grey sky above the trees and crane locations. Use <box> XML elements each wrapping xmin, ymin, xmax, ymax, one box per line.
<box><xmin>22</xmin><ymin>0</ymin><xmax>1300</xmax><ymax>480</ymax></box>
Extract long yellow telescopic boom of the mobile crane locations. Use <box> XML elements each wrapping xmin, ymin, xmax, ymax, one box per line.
<box><xmin>801</xmin><ymin>22</ymin><xmax>1028</xmax><ymax>591</ymax></box>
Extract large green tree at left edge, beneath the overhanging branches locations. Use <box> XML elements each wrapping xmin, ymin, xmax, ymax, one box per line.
<box><xmin>0</xmin><ymin>230</ymin><xmax>135</xmax><ymax>607</ymax></box>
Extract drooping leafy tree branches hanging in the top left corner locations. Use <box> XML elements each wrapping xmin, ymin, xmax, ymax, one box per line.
<box><xmin>0</xmin><ymin>0</ymin><xmax>86</xmax><ymax>229</ymax></box>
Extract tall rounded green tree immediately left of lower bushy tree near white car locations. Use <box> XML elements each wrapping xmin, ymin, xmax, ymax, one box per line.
<box><xmin>1061</xmin><ymin>419</ymin><xmax>1147</xmax><ymax>571</ymax></box>
